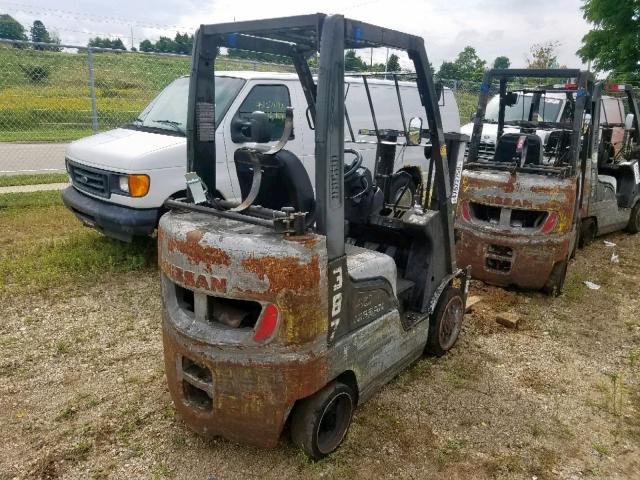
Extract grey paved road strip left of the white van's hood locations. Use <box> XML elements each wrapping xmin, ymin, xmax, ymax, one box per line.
<box><xmin>0</xmin><ymin>143</ymin><xmax>68</xmax><ymax>175</ymax></box>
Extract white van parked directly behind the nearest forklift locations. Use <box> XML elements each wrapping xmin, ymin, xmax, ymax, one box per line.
<box><xmin>62</xmin><ymin>71</ymin><xmax>460</xmax><ymax>241</ymax></box>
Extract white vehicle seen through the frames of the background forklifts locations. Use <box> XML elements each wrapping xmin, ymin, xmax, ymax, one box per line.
<box><xmin>460</xmin><ymin>92</ymin><xmax>625</xmax><ymax>159</ymax></box>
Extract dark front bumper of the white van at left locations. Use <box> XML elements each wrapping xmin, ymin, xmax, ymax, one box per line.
<box><xmin>62</xmin><ymin>186</ymin><xmax>160</xmax><ymax>242</ymax></box>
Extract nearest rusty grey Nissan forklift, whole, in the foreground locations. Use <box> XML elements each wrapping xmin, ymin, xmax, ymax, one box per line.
<box><xmin>158</xmin><ymin>14</ymin><xmax>468</xmax><ymax>458</ymax></box>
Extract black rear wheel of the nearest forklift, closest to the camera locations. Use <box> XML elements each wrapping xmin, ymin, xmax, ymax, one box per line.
<box><xmin>291</xmin><ymin>381</ymin><xmax>356</xmax><ymax>460</ymax></box>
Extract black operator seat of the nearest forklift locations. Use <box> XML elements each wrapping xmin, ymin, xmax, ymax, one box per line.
<box><xmin>233</xmin><ymin>148</ymin><xmax>316</xmax><ymax>224</ymax></box>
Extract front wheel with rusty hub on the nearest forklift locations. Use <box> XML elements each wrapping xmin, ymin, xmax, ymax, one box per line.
<box><xmin>425</xmin><ymin>286</ymin><xmax>464</xmax><ymax>357</ymax></box>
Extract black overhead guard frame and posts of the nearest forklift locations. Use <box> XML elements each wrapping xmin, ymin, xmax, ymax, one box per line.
<box><xmin>182</xmin><ymin>14</ymin><xmax>456</xmax><ymax>274</ymax></box>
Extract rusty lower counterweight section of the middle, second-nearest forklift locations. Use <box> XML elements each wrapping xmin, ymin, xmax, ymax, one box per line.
<box><xmin>456</xmin><ymin>225</ymin><xmax>572</xmax><ymax>290</ymax></box>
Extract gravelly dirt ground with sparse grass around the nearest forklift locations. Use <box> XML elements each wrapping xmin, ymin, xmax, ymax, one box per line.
<box><xmin>0</xmin><ymin>203</ymin><xmax>640</xmax><ymax>480</ymax></box>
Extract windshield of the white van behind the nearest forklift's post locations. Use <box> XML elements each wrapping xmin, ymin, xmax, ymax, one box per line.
<box><xmin>133</xmin><ymin>77</ymin><xmax>244</xmax><ymax>134</ymax></box>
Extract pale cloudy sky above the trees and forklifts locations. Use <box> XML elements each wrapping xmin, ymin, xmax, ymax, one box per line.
<box><xmin>0</xmin><ymin>0</ymin><xmax>589</xmax><ymax>68</ymax></box>
